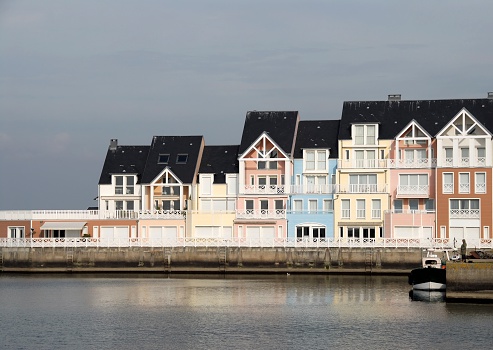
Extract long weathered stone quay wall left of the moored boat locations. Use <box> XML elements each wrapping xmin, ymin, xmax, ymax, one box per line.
<box><xmin>0</xmin><ymin>247</ymin><xmax>422</xmax><ymax>273</ymax></box>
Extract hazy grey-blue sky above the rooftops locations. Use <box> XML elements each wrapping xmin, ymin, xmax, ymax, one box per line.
<box><xmin>0</xmin><ymin>0</ymin><xmax>493</xmax><ymax>210</ymax></box>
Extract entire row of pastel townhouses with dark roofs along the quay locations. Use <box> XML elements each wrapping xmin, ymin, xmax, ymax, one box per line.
<box><xmin>0</xmin><ymin>93</ymin><xmax>493</xmax><ymax>245</ymax></box>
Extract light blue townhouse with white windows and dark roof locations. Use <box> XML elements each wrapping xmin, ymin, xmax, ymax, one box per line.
<box><xmin>287</xmin><ymin>120</ymin><xmax>339</xmax><ymax>241</ymax></box>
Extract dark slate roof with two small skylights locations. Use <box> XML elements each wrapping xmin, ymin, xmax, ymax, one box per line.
<box><xmin>142</xmin><ymin>136</ymin><xmax>203</xmax><ymax>184</ymax></box>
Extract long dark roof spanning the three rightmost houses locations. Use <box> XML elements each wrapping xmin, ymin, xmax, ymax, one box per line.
<box><xmin>339</xmin><ymin>98</ymin><xmax>493</xmax><ymax>140</ymax></box>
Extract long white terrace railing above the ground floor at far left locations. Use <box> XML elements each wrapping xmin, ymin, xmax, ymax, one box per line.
<box><xmin>0</xmin><ymin>210</ymin><xmax>186</xmax><ymax>220</ymax></box>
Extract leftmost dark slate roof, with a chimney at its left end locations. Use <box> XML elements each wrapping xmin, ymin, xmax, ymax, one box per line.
<box><xmin>99</xmin><ymin>146</ymin><xmax>149</xmax><ymax>185</ymax></box>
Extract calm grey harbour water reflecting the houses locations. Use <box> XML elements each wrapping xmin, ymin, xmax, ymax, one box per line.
<box><xmin>0</xmin><ymin>275</ymin><xmax>493</xmax><ymax>349</ymax></box>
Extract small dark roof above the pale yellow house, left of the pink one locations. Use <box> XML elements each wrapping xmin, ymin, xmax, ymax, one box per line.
<box><xmin>199</xmin><ymin>145</ymin><xmax>240</xmax><ymax>183</ymax></box>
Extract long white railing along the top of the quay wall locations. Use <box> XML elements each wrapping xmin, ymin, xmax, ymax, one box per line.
<box><xmin>0</xmin><ymin>238</ymin><xmax>493</xmax><ymax>249</ymax></box>
